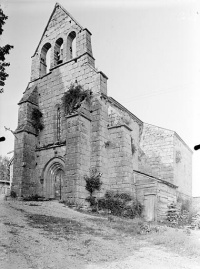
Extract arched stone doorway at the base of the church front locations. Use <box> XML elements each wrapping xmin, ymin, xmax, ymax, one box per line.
<box><xmin>43</xmin><ymin>157</ymin><xmax>65</xmax><ymax>200</ymax></box>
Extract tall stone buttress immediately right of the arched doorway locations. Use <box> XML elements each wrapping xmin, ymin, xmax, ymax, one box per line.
<box><xmin>64</xmin><ymin>108</ymin><xmax>91</xmax><ymax>200</ymax></box>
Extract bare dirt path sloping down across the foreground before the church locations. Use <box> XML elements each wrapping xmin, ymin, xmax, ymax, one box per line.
<box><xmin>0</xmin><ymin>197</ymin><xmax>200</xmax><ymax>269</ymax></box>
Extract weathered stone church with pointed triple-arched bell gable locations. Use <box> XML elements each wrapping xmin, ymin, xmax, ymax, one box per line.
<box><xmin>12</xmin><ymin>4</ymin><xmax>192</xmax><ymax>220</ymax></box>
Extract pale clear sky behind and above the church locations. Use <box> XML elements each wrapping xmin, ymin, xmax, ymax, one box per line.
<box><xmin>0</xmin><ymin>0</ymin><xmax>200</xmax><ymax>196</ymax></box>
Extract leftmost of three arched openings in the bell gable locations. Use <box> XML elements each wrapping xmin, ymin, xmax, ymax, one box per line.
<box><xmin>40</xmin><ymin>43</ymin><xmax>51</xmax><ymax>76</ymax></box>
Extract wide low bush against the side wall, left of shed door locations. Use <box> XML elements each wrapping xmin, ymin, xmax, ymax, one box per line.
<box><xmin>98</xmin><ymin>191</ymin><xmax>143</xmax><ymax>218</ymax></box>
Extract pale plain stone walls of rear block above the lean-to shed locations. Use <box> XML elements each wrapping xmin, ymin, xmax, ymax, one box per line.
<box><xmin>139</xmin><ymin>123</ymin><xmax>192</xmax><ymax>198</ymax></box>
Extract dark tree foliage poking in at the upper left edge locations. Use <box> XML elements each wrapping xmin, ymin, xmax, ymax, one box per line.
<box><xmin>0</xmin><ymin>7</ymin><xmax>13</xmax><ymax>93</ymax></box>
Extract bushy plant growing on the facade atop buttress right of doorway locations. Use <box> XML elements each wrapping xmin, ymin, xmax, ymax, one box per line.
<box><xmin>62</xmin><ymin>84</ymin><xmax>92</xmax><ymax>115</ymax></box>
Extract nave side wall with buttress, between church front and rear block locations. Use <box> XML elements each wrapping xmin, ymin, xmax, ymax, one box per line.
<box><xmin>100</xmin><ymin>97</ymin><xmax>142</xmax><ymax>195</ymax></box>
